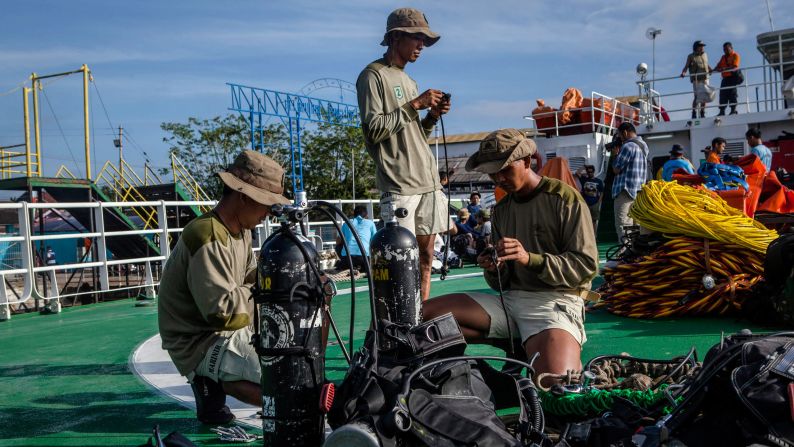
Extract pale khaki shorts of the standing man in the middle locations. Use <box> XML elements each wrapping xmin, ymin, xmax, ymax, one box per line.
<box><xmin>380</xmin><ymin>190</ymin><xmax>450</xmax><ymax>236</ymax></box>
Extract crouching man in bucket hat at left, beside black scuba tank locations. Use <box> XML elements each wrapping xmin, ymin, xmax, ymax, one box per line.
<box><xmin>158</xmin><ymin>151</ymin><xmax>289</xmax><ymax>424</ymax></box>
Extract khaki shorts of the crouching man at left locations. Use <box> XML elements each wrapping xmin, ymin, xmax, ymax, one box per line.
<box><xmin>188</xmin><ymin>327</ymin><xmax>261</xmax><ymax>383</ymax></box>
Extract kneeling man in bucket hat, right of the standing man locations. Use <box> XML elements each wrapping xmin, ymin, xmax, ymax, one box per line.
<box><xmin>424</xmin><ymin>129</ymin><xmax>598</xmax><ymax>384</ymax></box>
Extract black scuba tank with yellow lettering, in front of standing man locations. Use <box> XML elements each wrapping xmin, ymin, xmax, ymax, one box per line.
<box><xmin>370</xmin><ymin>208</ymin><xmax>422</xmax><ymax>349</ymax></box>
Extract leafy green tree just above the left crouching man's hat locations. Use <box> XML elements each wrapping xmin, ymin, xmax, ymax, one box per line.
<box><xmin>160</xmin><ymin>114</ymin><xmax>289</xmax><ymax>198</ymax></box>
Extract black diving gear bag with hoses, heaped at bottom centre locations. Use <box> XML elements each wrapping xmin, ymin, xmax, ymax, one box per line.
<box><xmin>325</xmin><ymin>314</ymin><xmax>545</xmax><ymax>447</ymax></box>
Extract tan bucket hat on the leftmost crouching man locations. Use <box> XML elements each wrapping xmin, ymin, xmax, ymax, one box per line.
<box><xmin>218</xmin><ymin>150</ymin><xmax>290</xmax><ymax>205</ymax></box>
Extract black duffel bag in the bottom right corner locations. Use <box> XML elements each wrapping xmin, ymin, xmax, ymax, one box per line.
<box><xmin>663</xmin><ymin>331</ymin><xmax>794</xmax><ymax>446</ymax></box>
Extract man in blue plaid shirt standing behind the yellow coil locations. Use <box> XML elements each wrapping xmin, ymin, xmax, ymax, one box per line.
<box><xmin>612</xmin><ymin>123</ymin><xmax>648</xmax><ymax>244</ymax></box>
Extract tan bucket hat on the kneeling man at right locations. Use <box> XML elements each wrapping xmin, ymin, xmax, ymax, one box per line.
<box><xmin>466</xmin><ymin>129</ymin><xmax>537</xmax><ymax>174</ymax></box>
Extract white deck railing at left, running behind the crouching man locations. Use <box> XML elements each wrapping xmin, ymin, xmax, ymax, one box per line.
<box><xmin>0</xmin><ymin>199</ymin><xmax>384</xmax><ymax>320</ymax></box>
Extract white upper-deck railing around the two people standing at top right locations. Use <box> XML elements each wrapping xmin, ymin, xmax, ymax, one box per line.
<box><xmin>637</xmin><ymin>61</ymin><xmax>794</xmax><ymax>123</ymax></box>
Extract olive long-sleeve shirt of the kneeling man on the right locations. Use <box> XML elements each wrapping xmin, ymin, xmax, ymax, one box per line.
<box><xmin>485</xmin><ymin>177</ymin><xmax>598</xmax><ymax>292</ymax></box>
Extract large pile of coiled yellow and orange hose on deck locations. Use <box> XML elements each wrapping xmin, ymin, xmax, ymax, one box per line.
<box><xmin>598</xmin><ymin>181</ymin><xmax>778</xmax><ymax>318</ymax></box>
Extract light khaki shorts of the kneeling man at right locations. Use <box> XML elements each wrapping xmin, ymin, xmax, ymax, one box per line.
<box><xmin>467</xmin><ymin>290</ymin><xmax>587</xmax><ymax>346</ymax></box>
